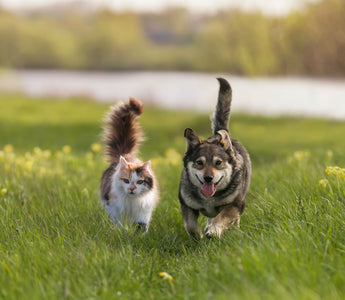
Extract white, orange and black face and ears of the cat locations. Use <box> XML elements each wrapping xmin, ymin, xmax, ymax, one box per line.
<box><xmin>119</xmin><ymin>156</ymin><xmax>153</xmax><ymax>196</ymax></box>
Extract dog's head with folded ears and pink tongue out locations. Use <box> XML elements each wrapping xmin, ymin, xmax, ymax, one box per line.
<box><xmin>183</xmin><ymin>128</ymin><xmax>237</xmax><ymax>197</ymax></box>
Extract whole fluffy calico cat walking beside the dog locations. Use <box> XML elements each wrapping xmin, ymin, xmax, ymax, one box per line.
<box><xmin>100</xmin><ymin>98</ymin><xmax>159</xmax><ymax>232</ymax></box>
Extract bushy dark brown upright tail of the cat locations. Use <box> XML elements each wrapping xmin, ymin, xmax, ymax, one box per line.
<box><xmin>103</xmin><ymin>98</ymin><xmax>143</xmax><ymax>163</ymax></box>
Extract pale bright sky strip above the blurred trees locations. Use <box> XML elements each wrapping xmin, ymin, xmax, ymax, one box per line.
<box><xmin>0</xmin><ymin>0</ymin><xmax>317</xmax><ymax>15</ymax></box>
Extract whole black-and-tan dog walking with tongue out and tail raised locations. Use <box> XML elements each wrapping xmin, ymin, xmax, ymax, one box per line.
<box><xmin>179</xmin><ymin>78</ymin><xmax>252</xmax><ymax>238</ymax></box>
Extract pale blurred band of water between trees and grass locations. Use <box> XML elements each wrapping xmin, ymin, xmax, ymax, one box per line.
<box><xmin>0</xmin><ymin>71</ymin><xmax>345</xmax><ymax>120</ymax></box>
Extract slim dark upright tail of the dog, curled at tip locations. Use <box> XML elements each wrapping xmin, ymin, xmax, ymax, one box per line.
<box><xmin>211</xmin><ymin>78</ymin><xmax>232</xmax><ymax>134</ymax></box>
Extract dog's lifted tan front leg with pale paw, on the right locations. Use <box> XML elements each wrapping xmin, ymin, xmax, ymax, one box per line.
<box><xmin>205</xmin><ymin>204</ymin><xmax>241</xmax><ymax>238</ymax></box>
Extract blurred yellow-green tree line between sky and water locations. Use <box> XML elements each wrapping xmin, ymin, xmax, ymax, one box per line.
<box><xmin>0</xmin><ymin>0</ymin><xmax>345</xmax><ymax>76</ymax></box>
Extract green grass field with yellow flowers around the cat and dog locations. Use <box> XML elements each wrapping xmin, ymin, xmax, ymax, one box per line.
<box><xmin>0</xmin><ymin>95</ymin><xmax>345</xmax><ymax>300</ymax></box>
